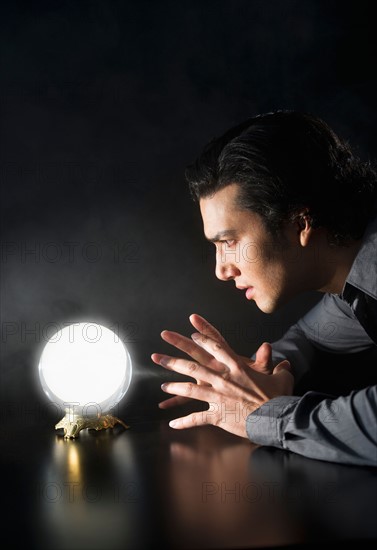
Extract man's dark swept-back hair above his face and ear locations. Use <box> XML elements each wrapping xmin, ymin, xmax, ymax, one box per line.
<box><xmin>185</xmin><ymin>110</ymin><xmax>377</xmax><ymax>245</ymax></box>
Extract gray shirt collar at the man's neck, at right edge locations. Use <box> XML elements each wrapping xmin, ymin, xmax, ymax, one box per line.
<box><xmin>344</xmin><ymin>217</ymin><xmax>377</xmax><ymax>299</ymax></box>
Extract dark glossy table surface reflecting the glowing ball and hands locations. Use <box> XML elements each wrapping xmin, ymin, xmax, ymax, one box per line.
<box><xmin>0</xmin><ymin>358</ymin><xmax>377</xmax><ymax>550</ymax></box>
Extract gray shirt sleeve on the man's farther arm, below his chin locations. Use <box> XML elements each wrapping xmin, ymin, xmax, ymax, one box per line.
<box><xmin>252</xmin><ymin>294</ymin><xmax>375</xmax><ymax>383</ymax></box>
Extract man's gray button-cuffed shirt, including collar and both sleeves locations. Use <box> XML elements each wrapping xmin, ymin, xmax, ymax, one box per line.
<box><xmin>246</xmin><ymin>213</ymin><xmax>377</xmax><ymax>466</ymax></box>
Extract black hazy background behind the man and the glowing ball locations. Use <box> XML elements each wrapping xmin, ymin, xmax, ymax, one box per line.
<box><xmin>0</xmin><ymin>0</ymin><xmax>377</xmax><ymax>412</ymax></box>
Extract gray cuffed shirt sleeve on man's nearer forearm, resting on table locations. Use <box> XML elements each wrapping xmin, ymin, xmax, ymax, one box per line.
<box><xmin>246</xmin><ymin>386</ymin><xmax>377</xmax><ymax>466</ymax></box>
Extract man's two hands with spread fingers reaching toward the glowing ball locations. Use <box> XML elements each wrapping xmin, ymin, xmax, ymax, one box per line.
<box><xmin>152</xmin><ymin>315</ymin><xmax>293</xmax><ymax>437</ymax></box>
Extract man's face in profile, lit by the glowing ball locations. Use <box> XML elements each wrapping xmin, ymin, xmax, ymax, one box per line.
<box><xmin>200</xmin><ymin>184</ymin><xmax>305</xmax><ymax>313</ymax></box>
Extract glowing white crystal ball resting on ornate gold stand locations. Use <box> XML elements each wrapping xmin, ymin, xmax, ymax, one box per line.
<box><xmin>39</xmin><ymin>323</ymin><xmax>132</xmax><ymax>414</ymax></box>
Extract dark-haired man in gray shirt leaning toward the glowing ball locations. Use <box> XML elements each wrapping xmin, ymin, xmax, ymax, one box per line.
<box><xmin>152</xmin><ymin>111</ymin><xmax>377</xmax><ymax>466</ymax></box>
